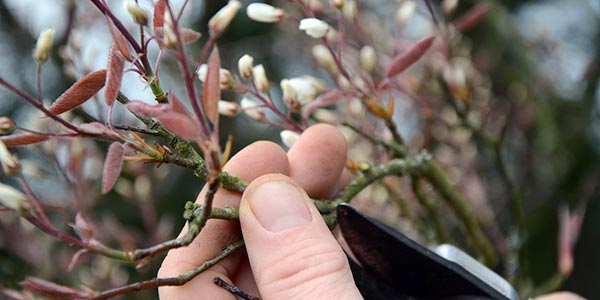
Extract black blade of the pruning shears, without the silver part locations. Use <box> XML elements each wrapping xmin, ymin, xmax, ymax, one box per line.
<box><xmin>337</xmin><ymin>204</ymin><xmax>507</xmax><ymax>300</ymax></box>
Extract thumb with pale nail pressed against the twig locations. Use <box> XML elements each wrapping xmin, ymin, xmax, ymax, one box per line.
<box><xmin>240</xmin><ymin>174</ymin><xmax>362</xmax><ymax>300</ymax></box>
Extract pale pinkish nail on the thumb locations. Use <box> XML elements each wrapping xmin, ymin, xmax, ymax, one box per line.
<box><xmin>250</xmin><ymin>181</ymin><xmax>312</xmax><ymax>232</ymax></box>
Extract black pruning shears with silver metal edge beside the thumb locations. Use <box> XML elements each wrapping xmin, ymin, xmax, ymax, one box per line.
<box><xmin>337</xmin><ymin>204</ymin><xmax>519</xmax><ymax>300</ymax></box>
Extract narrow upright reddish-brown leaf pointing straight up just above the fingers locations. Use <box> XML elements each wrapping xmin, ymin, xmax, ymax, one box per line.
<box><xmin>202</xmin><ymin>46</ymin><xmax>221</xmax><ymax>125</ymax></box>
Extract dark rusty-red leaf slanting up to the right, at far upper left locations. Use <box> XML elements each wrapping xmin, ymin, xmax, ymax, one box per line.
<box><xmin>48</xmin><ymin>70</ymin><xmax>106</xmax><ymax>115</ymax></box>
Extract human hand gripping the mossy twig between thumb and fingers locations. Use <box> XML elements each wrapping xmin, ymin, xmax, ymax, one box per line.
<box><xmin>158</xmin><ymin>124</ymin><xmax>362</xmax><ymax>300</ymax></box>
